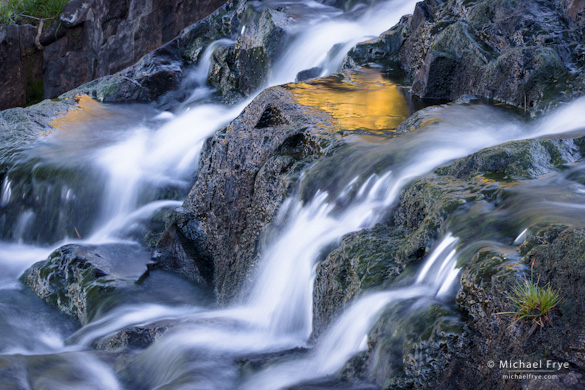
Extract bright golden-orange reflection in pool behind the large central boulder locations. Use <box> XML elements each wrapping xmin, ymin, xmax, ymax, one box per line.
<box><xmin>287</xmin><ymin>69</ymin><xmax>409</xmax><ymax>134</ymax></box>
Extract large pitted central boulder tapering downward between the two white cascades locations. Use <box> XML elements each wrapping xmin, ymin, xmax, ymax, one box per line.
<box><xmin>181</xmin><ymin>87</ymin><xmax>337</xmax><ymax>303</ymax></box>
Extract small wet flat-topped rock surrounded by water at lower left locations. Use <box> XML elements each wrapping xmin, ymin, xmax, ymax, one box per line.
<box><xmin>21</xmin><ymin>244</ymin><xmax>150</xmax><ymax>325</ymax></box>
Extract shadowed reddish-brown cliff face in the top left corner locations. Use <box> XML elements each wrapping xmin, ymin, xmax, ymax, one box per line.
<box><xmin>0</xmin><ymin>0</ymin><xmax>225</xmax><ymax>110</ymax></box>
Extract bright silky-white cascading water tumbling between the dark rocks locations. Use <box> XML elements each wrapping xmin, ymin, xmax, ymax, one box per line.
<box><xmin>0</xmin><ymin>1</ymin><xmax>585</xmax><ymax>390</ymax></box>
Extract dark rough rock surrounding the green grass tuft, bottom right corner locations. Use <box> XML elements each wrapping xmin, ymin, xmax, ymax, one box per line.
<box><xmin>432</xmin><ymin>225</ymin><xmax>585</xmax><ymax>389</ymax></box>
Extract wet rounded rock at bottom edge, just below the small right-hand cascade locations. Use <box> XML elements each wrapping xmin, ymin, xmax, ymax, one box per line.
<box><xmin>341</xmin><ymin>303</ymin><xmax>463</xmax><ymax>389</ymax></box>
